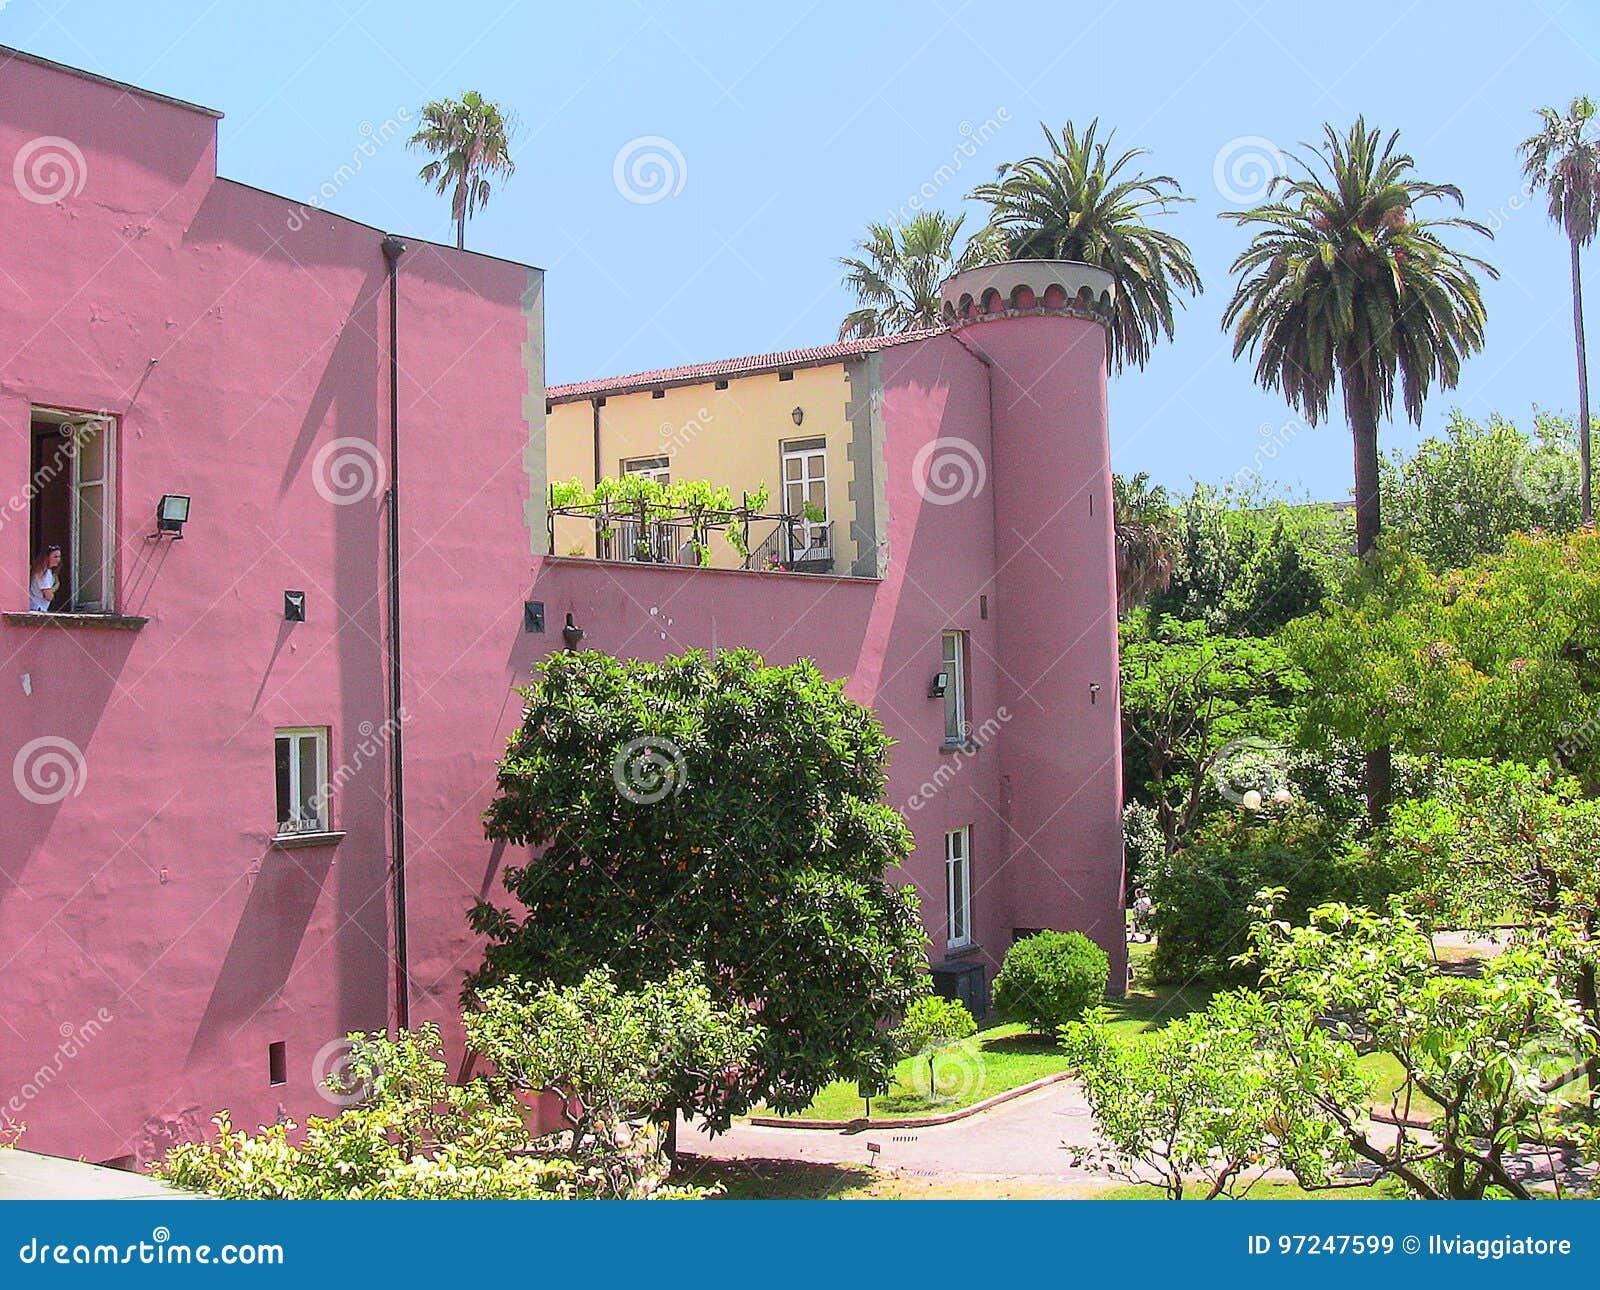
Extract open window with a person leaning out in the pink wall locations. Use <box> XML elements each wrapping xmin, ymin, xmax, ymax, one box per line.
<box><xmin>29</xmin><ymin>408</ymin><xmax>117</xmax><ymax>615</ymax></box>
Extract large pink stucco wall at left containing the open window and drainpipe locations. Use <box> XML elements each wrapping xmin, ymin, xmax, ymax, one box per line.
<box><xmin>0</xmin><ymin>50</ymin><xmax>542</xmax><ymax>1160</ymax></box>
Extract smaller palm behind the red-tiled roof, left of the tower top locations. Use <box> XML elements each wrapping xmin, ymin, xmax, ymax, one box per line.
<box><xmin>838</xmin><ymin>211</ymin><xmax>982</xmax><ymax>341</ymax></box>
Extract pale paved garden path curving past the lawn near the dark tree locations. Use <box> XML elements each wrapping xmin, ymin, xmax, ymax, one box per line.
<box><xmin>678</xmin><ymin>1082</ymin><xmax>1104</xmax><ymax>1183</ymax></box>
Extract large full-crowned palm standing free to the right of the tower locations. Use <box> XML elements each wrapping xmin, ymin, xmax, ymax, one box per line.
<box><xmin>1222</xmin><ymin>117</ymin><xmax>1498</xmax><ymax>823</ymax></box>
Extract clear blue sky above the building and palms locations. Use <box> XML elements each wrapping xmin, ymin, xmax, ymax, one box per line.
<box><xmin>0</xmin><ymin>0</ymin><xmax>1600</xmax><ymax>498</ymax></box>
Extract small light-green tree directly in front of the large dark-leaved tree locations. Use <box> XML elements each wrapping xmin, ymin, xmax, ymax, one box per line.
<box><xmin>464</xmin><ymin>968</ymin><xmax>760</xmax><ymax>1194</ymax></box>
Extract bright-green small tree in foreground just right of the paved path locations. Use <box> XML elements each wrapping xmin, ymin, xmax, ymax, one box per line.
<box><xmin>1061</xmin><ymin>992</ymin><xmax>1365</xmax><ymax>1200</ymax></box>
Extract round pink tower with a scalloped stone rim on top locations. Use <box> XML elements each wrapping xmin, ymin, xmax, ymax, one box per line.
<box><xmin>942</xmin><ymin>259</ymin><xmax>1126</xmax><ymax>994</ymax></box>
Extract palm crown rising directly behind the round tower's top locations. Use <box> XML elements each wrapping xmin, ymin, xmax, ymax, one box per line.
<box><xmin>973</xmin><ymin>120</ymin><xmax>1200</xmax><ymax>371</ymax></box>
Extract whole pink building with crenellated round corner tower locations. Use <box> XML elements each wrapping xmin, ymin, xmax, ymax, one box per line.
<box><xmin>0</xmin><ymin>50</ymin><xmax>1123</xmax><ymax>1162</ymax></box>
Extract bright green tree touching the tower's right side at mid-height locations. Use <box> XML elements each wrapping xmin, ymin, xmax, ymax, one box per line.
<box><xmin>1122</xmin><ymin>611</ymin><xmax>1306</xmax><ymax>853</ymax></box>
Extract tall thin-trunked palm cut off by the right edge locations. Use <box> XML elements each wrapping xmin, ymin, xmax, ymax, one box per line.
<box><xmin>1520</xmin><ymin>96</ymin><xmax>1600</xmax><ymax>523</ymax></box>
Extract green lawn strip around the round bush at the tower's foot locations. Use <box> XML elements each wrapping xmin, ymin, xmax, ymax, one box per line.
<box><xmin>764</xmin><ymin>986</ymin><xmax>1210</xmax><ymax>1120</ymax></box>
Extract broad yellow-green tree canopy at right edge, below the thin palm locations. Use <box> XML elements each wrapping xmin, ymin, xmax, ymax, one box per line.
<box><xmin>1283</xmin><ymin>530</ymin><xmax>1600</xmax><ymax>779</ymax></box>
